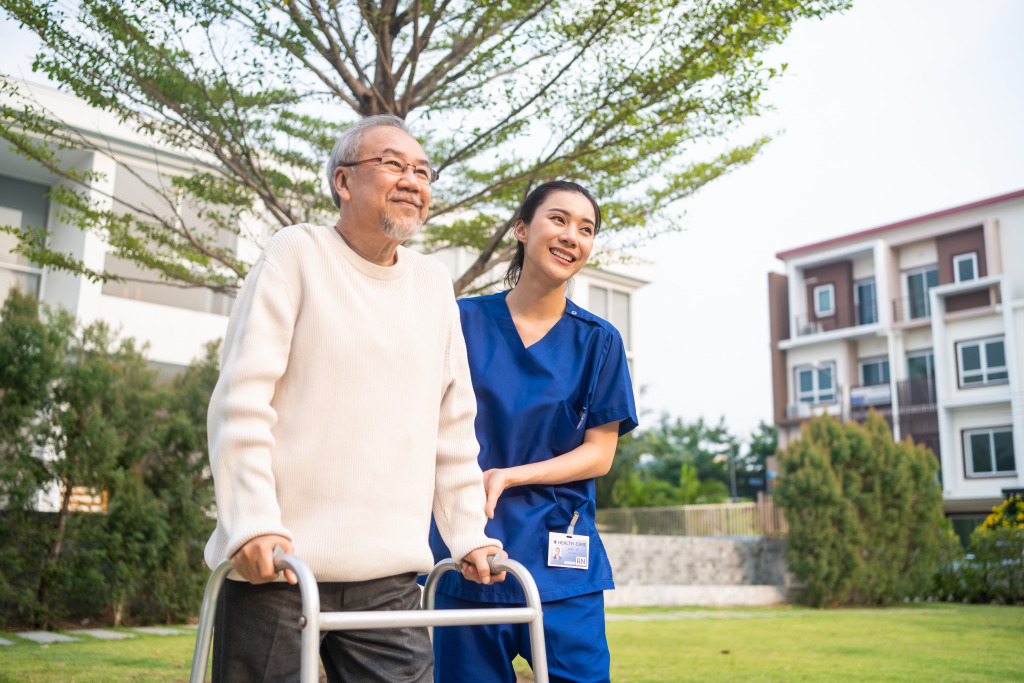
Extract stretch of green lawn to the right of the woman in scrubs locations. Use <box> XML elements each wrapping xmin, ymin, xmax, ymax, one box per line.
<box><xmin>607</xmin><ymin>603</ymin><xmax>1024</xmax><ymax>683</ymax></box>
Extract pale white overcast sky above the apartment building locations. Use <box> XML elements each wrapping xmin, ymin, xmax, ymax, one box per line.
<box><xmin>0</xmin><ymin>0</ymin><xmax>1024</xmax><ymax>444</ymax></box>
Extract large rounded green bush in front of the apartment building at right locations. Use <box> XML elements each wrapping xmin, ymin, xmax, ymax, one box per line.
<box><xmin>775</xmin><ymin>412</ymin><xmax>944</xmax><ymax>606</ymax></box>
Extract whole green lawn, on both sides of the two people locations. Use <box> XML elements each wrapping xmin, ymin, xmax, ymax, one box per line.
<box><xmin>0</xmin><ymin>603</ymin><xmax>1024</xmax><ymax>683</ymax></box>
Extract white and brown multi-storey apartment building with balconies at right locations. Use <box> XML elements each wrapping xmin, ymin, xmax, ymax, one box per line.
<box><xmin>768</xmin><ymin>189</ymin><xmax>1024</xmax><ymax>531</ymax></box>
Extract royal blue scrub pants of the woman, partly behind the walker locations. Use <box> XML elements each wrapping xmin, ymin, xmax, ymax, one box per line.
<box><xmin>434</xmin><ymin>591</ymin><xmax>610</xmax><ymax>683</ymax></box>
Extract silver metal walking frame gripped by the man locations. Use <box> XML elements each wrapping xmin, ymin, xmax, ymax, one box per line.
<box><xmin>188</xmin><ymin>548</ymin><xmax>548</xmax><ymax>683</ymax></box>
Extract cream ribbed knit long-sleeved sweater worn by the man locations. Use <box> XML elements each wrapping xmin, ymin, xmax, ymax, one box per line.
<box><xmin>206</xmin><ymin>224</ymin><xmax>501</xmax><ymax>581</ymax></box>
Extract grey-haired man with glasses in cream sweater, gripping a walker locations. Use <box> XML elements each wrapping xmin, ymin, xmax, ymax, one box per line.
<box><xmin>206</xmin><ymin>116</ymin><xmax>501</xmax><ymax>682</ymax></box>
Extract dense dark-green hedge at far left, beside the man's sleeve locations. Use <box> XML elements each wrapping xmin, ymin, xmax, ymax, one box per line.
<box><xmin>0</xmin><ymin>291</ymin><xmax>217</xmax><ymax>627</ymax></box>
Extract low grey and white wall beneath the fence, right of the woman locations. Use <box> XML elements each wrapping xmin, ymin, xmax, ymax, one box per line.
<box><xmin>601</xmin><ymin>533</ymin><xmax>788</xmax><ymax>607</ymax></box>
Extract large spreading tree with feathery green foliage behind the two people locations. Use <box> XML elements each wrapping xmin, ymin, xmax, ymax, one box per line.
<box><xmin>0</xmin><ymin>0</ymin><xmax>850</xmax><ymax>293</ymax></box>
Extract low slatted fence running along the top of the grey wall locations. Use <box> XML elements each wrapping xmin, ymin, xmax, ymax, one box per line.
<box><xmin>597</xmin><ymin>495</ymin><xmax>788</xmax><ymax>536</ymax></box>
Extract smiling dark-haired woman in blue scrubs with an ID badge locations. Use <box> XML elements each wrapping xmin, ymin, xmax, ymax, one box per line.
<box><xmin>431</xmin><ymin>180</ymin><xmax>637</xmax><ymax>683</ymax></box>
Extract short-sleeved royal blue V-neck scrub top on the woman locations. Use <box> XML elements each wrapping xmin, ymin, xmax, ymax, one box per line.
<box><xmin>430</xmin><ymin>292</ymin><xmax>637</xmax><ymax>602</ymax></box>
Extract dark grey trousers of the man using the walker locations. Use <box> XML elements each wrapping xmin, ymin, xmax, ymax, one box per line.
<box><xmin>213</xmin><ymin>573</ymin><xmax>434</xmax><ymax>683</ymax></box>
